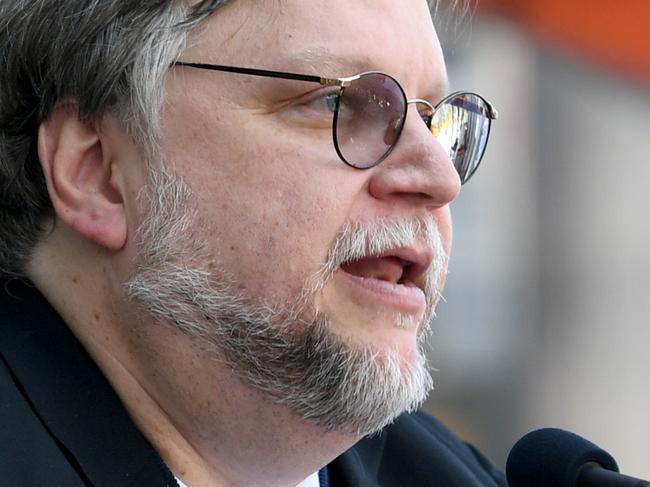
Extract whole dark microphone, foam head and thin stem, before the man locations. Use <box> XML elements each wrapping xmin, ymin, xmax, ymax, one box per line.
<box><xmin>506</xmin><ymin>428</ymin><xmax>650</xmax><ymax>487</ymax></box>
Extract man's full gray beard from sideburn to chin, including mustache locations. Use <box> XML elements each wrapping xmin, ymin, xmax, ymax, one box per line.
<box><xmin>125</xmin><ymin>169</ymin><xmax>446</xmax><ymax>436</ymax></box>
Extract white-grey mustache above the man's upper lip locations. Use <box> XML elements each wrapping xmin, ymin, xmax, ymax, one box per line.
<box><xmin>305</xmin><ymin>214</ymin><xmax>448</xmax><ymax>303</ymax></box>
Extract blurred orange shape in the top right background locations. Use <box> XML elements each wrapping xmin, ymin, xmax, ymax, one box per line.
<box><xmin>470</xmin><ymin>0</ymin><xmax>650</xmax><ymax>87</ymax></box>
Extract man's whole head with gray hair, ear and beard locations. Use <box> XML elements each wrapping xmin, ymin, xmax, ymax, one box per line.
<box><xmin>0</xmin><ymin>0</ymin><xmax>486</xmax><ymax>440</ymax></box>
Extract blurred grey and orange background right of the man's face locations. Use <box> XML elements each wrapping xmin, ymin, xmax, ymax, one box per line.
<box><xmin>426</xmin><ymin>0</ymin><xmax>650</xmax><ymax>479</ymax></box>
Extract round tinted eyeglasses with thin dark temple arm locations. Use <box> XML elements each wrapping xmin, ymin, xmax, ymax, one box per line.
<box><xmin>172</xmin><ymin>61</ymin><xmax>497</xmax><ymax>184</ymax></box>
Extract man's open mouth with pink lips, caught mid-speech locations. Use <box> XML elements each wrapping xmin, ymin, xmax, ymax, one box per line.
<box><xmin>340</xmin><ymin>247</ymin><xmax>433</xmax><ymax>314</ymax></box>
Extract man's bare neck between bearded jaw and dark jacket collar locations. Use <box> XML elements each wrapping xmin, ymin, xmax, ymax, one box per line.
<box><xmin>30</xmin><ymin>230</ymin><xmax>358</xmax><ymax>487</ymax></box>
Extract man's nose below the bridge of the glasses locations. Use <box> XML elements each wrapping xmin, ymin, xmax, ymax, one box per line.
<box><xmin>368</xmin><ymin>106</ymin><xmax>460</xmax><ymax>208</ymax></box>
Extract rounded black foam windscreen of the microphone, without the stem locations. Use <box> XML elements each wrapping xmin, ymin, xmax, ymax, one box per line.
<box><xmin>506</xmin><ymin>428</ymin><xmax>618</xmax><ymax>487</ymax></box>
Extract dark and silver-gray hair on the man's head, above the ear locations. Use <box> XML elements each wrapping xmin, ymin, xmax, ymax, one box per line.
<box><xmin>0</xmin><ymin>0</ymin><xmax>228</xmax><ymax>275</ymax></box>
